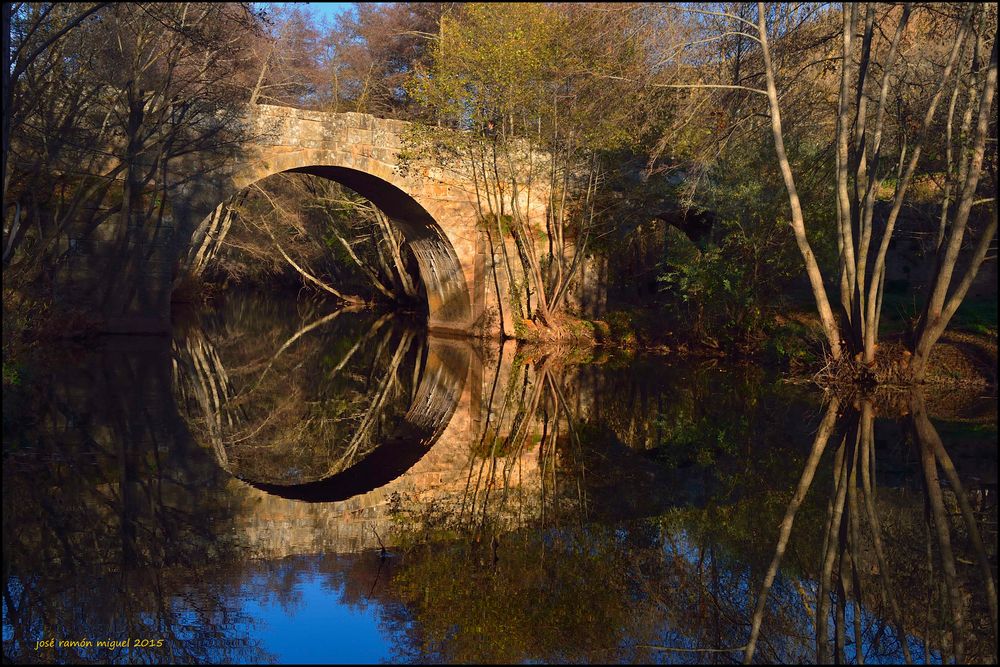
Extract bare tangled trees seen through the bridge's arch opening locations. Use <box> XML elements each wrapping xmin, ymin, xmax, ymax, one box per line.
<box><xmin>196</xmin><ymin>173</ymin><xmax>423</xmax><ymax>309</ymax></box>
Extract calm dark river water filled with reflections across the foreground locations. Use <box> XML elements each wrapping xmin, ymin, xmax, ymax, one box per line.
<box><xmin>3</xmin><ymin>296</ymin><xmax>997</xmax><ymax>663</ymax></box>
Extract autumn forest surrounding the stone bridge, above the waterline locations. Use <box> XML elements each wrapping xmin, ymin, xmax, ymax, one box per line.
<box><xmin>3</xmin><ymin>3</ymin><xmax>997</xmax><ymax>382</ymax></box>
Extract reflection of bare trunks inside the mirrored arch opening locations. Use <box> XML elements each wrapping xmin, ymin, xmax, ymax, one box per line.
<box><xmin>175</xmin><ymin>299</ymin><xmax>426</xmax><ymax>484</ymax></box>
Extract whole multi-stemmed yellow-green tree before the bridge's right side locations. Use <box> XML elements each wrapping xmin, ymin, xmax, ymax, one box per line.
<box><xmin>405</xmin><ymin>3</ymin><xmax>653</xmax><ymax>323</ymax></box>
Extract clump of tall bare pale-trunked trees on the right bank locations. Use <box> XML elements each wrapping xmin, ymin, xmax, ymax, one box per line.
<box><xmin>658</xmin><ymin>3</ymin><xmax>996</xmax><ymax>381</ymax></box>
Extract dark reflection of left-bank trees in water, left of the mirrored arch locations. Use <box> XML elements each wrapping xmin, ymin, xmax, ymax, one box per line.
<box><xmin>3</xmin><ymin>340</ymin><xmax>267</xmax><ymax>662</ymax></box>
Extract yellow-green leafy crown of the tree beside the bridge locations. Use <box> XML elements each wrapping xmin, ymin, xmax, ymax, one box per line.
<box><xmin>413</xmin><ymin>3</ymin><xmax>642</xmax><ymax>150</ymax></box>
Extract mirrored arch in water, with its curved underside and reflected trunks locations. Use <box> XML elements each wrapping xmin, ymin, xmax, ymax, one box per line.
<box><xmin>174</xmin><ymin>299</ymin><xmax>469</xmax><ymax>501</ymax></box>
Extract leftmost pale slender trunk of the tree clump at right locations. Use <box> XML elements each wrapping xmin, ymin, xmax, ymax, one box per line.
<box><xmin>757</xmin><ymin>2</ymin><xmax>841</xmax><ymax>359</ymax></box>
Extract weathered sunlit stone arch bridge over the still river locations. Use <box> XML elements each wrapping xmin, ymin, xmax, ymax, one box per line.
<box><xmin>157</xmin><ymin>105</ymin><xmax>524</xmax><ymax>335</ymax></box>
